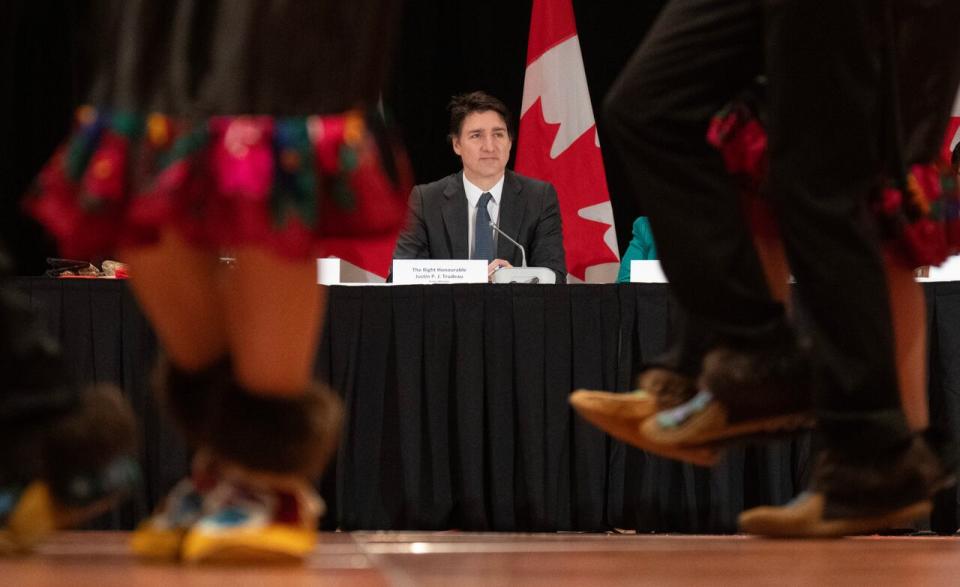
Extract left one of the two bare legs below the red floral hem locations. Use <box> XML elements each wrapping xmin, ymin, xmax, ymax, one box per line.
<box><xmin>120</xmin><ymin>229</ymin><xmax>229</xmax><ymax>559</ymax></box>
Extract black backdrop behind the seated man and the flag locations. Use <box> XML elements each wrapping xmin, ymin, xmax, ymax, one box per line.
<box><xmin>0</xmin><ymin>0</ymin><xmax>666</xmax><ymax>275</ymax></box>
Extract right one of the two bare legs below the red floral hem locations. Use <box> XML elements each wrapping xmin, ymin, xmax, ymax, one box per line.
<box><xmin>174</xmin><ymin>247</ymin><xmax>341</xmax><ymax>562</ymax></box>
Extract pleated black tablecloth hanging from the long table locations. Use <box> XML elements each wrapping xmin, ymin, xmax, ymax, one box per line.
<box><xmin>15</xmin><ymin>278</ymin><xmax>960</xmax><ymax>532</ymax></box>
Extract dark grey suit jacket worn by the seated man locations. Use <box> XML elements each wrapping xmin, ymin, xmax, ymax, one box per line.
<box><xmin>393</xmin><ymin>170</ymin><xmax>567</xmax><ymax>283</ymax></box>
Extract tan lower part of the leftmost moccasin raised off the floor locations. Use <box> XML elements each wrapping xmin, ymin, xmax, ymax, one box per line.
<box><xmin>570</xmin><ymin>390</ymin><xmax>720</xmax><ymax>467</ymax></box>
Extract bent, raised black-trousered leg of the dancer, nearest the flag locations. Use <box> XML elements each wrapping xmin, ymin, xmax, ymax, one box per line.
<box><xmin>604</xmin><ymin>0</ymin><xmax>783</xmax><ymax>346</ymax></box>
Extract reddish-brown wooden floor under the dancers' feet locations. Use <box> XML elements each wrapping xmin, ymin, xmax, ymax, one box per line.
<box><xmin>0</xmin><ymin>532</ymin><xmax>960</xmax><ymax>587</ymax></box>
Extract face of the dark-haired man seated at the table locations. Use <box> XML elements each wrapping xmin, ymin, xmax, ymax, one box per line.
<box><xmin>453</xmin><ymin>110</ymin><xmax>513</xmax><ymax>187</ymax></box>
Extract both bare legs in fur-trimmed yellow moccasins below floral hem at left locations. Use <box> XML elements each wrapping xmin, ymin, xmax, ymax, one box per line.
<box><xmin>128</xmin><ymin>238</ymin><xmax>332</xmax><ymax>562</ymax></box>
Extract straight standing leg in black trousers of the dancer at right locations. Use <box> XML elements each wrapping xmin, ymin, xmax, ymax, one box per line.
<box><xmin>765</xmin><ymin>0</ymin><xmax>909</xmax><ymax>451</ymax></box>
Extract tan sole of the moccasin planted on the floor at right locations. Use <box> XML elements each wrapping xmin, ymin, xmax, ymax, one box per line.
<box><xmin>739</xmin><ymin>500</ymin><xmax>933</xmax><ymax>538</ymax></box>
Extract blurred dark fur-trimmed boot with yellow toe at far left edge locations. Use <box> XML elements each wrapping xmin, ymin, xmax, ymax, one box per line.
<box><xmin>0</xmin><ymin>385</ymin><xmax>140</xmax><ymax>553</ymax></box>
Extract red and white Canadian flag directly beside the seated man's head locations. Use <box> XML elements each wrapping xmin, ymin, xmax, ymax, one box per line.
<box><xmin>516</xmin><ymin>0</ymin><xmax>620</xmax><ymax>283</ymax></box>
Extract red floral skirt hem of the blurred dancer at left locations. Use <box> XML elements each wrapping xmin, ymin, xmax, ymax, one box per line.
<box><xmin>26</xmin><ymin>106</ymin><xmax>411</xmax><ymax>274</ymax></box>
